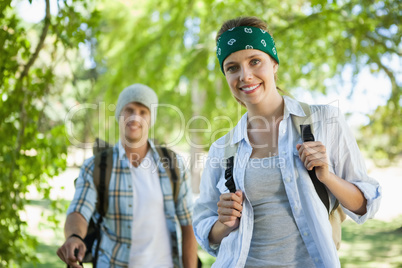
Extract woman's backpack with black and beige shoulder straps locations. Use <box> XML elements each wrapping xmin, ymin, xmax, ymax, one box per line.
<box><xmin>224</xmin><ymin>102</ymin><xmax>346</xmax><ymax>250</ymax></box>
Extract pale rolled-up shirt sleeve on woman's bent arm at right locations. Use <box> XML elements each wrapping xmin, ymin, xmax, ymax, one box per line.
<box><xmin>325</xmin><ymin>107</ymin><xmax>382</xmax><ymax>224</ymax></box>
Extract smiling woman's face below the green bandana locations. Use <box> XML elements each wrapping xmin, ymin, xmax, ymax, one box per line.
<box><xmin>223</xmin><ymin>49</ymin><xmax>278</xmax><ymax>108</ymax></box>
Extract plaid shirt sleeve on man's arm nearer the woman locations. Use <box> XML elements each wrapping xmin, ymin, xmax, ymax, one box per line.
<box><xmin>176</xmin><ymin>155</ymin><xmax>193</xmax><ymax>226</ymax></box>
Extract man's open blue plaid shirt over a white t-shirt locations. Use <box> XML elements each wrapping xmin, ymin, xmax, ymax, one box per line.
<box><xmin>67</xmin><ymin>141</ymin><xmax>193</xmax><ymax>267</ymax></box>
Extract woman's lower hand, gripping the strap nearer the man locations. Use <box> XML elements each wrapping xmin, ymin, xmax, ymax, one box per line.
<box><xmin>218</xmin><ymin>190</ymin><xmax>243</xmax><ymax>231</ymax></box>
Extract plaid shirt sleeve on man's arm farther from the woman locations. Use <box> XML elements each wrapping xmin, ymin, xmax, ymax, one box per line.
<box><xmin>67</xmin><ymin>157</ymin><xmax>97</xmax><ymax>222</ymax></box>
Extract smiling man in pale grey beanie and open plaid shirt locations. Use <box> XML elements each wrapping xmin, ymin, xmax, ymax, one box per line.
<box><xmin>57</xmin><ymin>84</ymin><xmax>197</xmax><ymax>267</ymax></box>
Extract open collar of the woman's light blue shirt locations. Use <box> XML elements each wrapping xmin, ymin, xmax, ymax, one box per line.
<box><xmin>227</xmin><ymin>96</ymin><xmax>306</xmax><ymax>144</ymax></box>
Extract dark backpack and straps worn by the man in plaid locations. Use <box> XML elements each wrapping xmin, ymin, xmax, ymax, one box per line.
<box><xmin>82</xmin><ymin>138</ymin><xmax>180</xmax><ymax>268</ymax></box>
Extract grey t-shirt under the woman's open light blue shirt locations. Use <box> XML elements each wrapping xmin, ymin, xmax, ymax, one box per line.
<box><xmin>244</xmin><ymin>156</ymin><xmax>315</xmax><ymax>268</ymax></box>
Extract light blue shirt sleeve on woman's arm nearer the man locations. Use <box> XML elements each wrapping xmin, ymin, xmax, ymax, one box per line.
<box><xmin>193</xmin><ymin>140</ymin><xmax>223</xmax><ymax>257</ymax></box>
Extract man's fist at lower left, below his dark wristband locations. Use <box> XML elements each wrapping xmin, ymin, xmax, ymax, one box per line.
<box><xmin>57</xmin><ymin>236</ymin><xmax>86</xmax><ymax>268</ymax></box>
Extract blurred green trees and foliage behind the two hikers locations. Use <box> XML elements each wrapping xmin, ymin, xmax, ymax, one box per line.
<box><xmin>0</xmin><ymin>0</ymin><xmax>402</xmax><ymax>267</ymax></box>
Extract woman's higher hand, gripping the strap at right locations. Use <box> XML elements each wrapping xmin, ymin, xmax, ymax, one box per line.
<box><xmin>296</xmin><ymin>141</ymin><xmax>329</xmax><ymax>183</ymax></box>
